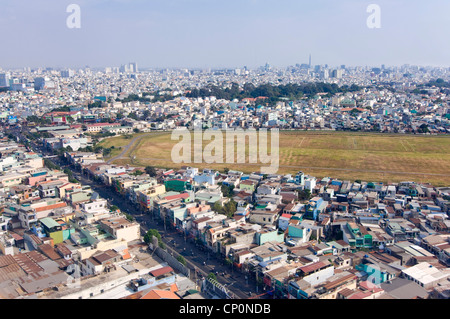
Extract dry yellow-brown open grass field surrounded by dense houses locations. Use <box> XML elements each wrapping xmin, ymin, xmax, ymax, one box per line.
<box><xmin>100</xmin><ymin>131</ymin><xmax>450</xmax><ymax>186</ymax></box>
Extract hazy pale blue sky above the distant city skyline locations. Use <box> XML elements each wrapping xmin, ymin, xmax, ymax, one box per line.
<box><xmin>0</xmin><ymin>0</ymin><xmax>450</xmax><ymax>68</ymax></box>
